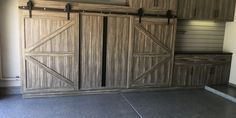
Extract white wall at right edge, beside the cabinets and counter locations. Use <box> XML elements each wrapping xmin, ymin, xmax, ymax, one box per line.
<box><xmin>224</xmin><ymin>6</ymin><xmax>236</xmax><ymax>85</ymax></box>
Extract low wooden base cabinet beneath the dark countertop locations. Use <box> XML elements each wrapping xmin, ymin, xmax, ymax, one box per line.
<box><xmin>172</xmin><ymin>54</ymin><xmax>232</xmax><ymax>87</ymax></box>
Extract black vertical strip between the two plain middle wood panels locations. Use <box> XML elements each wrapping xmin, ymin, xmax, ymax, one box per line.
<box><xmin>102</xmin><ymin>16</ymin><xmax>108</xmax><ymax>87</ymax></box>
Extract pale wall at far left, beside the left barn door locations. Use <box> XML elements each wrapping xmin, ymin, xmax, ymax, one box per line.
<box><xmin>0</xmin><ymin>0</ymin><xmax>20</xmax><ymax>86</ymax></box>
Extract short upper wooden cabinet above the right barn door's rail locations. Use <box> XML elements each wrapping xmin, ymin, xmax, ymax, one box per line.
<box><xmin>129</xmin><ymin>0</ymin><xmax>177</xmax><ymax>11</ymax></box>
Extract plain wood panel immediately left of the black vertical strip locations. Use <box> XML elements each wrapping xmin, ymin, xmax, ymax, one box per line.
<box><xmin>80</xmin><ymin>14</ymin><xmax>103</xmax><ymax>90</ymax></box>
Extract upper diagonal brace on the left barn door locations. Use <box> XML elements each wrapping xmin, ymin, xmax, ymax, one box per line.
<box><xmin>26</xmin><ymin>21</ymin><xmax>75</xmax><ymax>52</ymax></box>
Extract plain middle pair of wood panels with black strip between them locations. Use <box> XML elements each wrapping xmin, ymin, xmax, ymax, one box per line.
<box><xmin>80</xmin><ymin>13</ymin><xmax>130</xmax><ymax>90</ymax></box>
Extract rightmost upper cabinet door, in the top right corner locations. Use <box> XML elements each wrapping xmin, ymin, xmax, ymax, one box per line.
<box><xmin>215</xmin><ymin>0</ymin><xmax>236</xmax><ymax>21</ymax></box>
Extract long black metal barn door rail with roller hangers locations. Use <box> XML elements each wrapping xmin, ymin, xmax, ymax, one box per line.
<box><xmin>19</xmin><ymin>0</ymin><xmax>177</xmax><ymax>23</ymax></box>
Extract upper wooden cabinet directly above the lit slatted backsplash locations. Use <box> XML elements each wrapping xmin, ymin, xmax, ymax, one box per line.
<box><xmin>177</xmin><ymin>0</ymin><xmax>236</xmax><ymax>21</ymax></box>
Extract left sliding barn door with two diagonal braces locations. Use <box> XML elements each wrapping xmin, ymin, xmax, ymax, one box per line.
<box><xmin>22</xmin><ymin>11</ymin><xmax>79</xmax><ymax>93</ymax></box>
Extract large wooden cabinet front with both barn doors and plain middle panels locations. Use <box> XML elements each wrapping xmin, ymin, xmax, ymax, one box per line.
<box><xmin>18</xmin><ymin>0</ymin><xmax>177</xmax><ymax>97</ymax></box>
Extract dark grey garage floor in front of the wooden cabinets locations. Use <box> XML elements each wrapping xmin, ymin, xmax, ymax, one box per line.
<box><xmin>0</xmin><ymin>89</ymin><xmax>236</xmax><ymax>118</ymax></box>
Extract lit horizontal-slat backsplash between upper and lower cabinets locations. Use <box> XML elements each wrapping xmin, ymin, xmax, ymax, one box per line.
<box><xmin>176</xmin><ymin>20</ymin><xmax>225</xmax><ymax>51</ymax></box>
